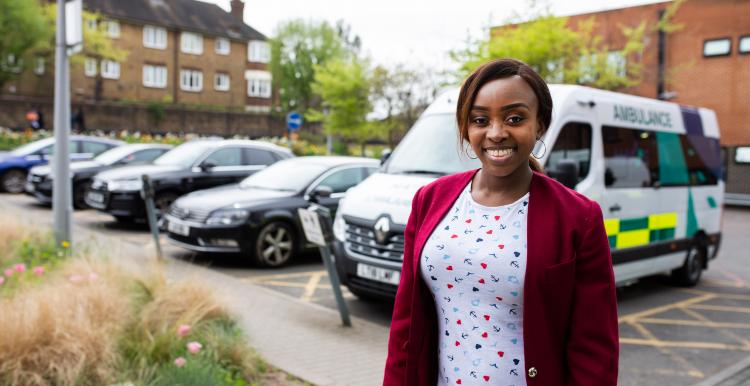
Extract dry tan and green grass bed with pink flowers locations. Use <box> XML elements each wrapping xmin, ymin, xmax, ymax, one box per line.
<box><xmin>0</xmin><ymin>220</ymin><xmax>301</xmax><ymax>386</ymax></box>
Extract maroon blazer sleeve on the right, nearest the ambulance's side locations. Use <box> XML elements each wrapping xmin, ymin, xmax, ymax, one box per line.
<box><xmin>565</xmin><ymin>201</ymin><xmax>619</xmax><ymax>386</ymax></box>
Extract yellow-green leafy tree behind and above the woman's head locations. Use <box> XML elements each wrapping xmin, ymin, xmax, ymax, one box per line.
<box><xmin>451</xmin><ymin>0</ymin><xmax>684</xmax><ymax>90</ymax></box>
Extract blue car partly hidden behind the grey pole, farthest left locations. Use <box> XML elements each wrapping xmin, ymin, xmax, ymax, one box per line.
<box><xmin>0</xmin><ymin>135</ymin><xmax>125</xmax><ymax>193</ymax></box>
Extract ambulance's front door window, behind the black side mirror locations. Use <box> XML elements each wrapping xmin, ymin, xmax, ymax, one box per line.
<box><xmin>545</xmin><ymin>122</ymin><xmax>591</xmax><ymax>182</ymax></box>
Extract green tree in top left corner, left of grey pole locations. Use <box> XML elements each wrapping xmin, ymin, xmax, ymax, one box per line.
<box><xmin>0</xmin><ymin>0</ymin><xmax>54</xmax><ymax>87</ymax></box>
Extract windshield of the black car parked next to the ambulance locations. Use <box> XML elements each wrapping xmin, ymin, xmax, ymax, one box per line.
<box><xmin>240</xmin><ymin>158</ymin><xmax>328</xmax><ymax>192</ymax></box>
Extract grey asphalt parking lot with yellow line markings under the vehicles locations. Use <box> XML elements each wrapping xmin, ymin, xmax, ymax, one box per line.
<box><xmin>0</xmin><ymin>194</ymin><xmax>750</xmax><ymax>385</ymax></box>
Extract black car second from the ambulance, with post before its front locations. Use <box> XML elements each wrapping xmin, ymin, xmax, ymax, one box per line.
<box><xmin>86</xmin><ymin>140</ymin><xmax>294</xmax><ymax>221</ymax></box>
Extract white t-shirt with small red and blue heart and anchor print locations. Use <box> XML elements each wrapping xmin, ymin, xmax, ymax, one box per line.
<box><xmin>420</xmin><ymin>182</ymin><xmax>529</xmax><ymax>386</ymax></box>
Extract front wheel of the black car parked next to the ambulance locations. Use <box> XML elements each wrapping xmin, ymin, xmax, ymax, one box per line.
<box><xmin>252</xmin><ymin>221</ymin><xmax>297</xmax><ymax>267</ymax></box>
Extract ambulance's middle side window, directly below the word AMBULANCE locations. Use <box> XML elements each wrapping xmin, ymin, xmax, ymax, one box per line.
<box><xmin>602</xmin><ymin>126</ymin><xmax>659</xmax><ymax>188</ymax></box>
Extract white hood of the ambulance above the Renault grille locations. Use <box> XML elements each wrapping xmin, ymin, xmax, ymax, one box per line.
<box><xmin>339</xmin><ymin>173</ymin><xmax>436</xmax><ymax>225</ymax></box>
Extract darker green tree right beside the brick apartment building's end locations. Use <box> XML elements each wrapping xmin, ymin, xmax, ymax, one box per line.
<box><xmin>270</xmin><ymin>19</ymin><xmax>360</xmax><ymax>114</ymax></box>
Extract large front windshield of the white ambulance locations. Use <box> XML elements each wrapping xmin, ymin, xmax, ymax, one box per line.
<box><xmin>385</xmin><ymin>114</ymin><xmax>481</xmax><ymax>175</ymax></box>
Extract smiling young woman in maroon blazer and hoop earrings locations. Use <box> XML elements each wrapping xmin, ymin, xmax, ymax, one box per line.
<box><xmin>384</xmin><ymin>59</ymin><xmax>619</xmax><ymax>386</ymax></box>
